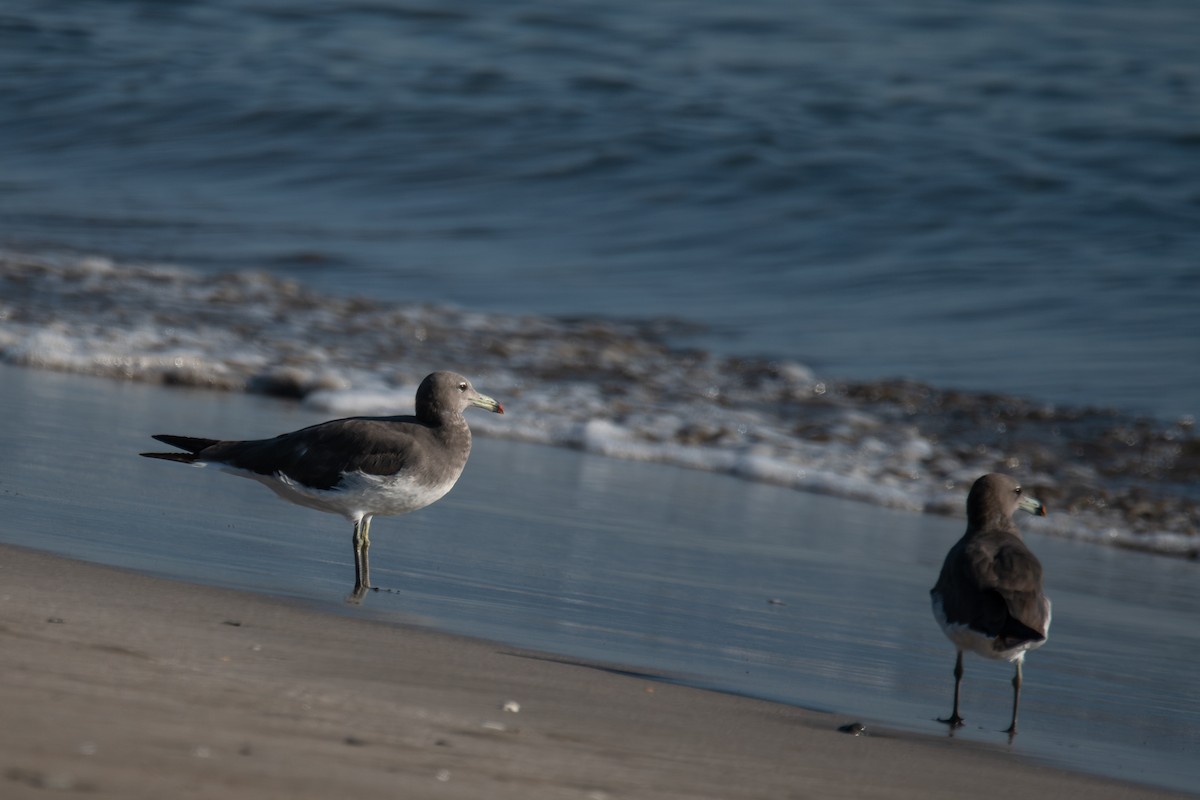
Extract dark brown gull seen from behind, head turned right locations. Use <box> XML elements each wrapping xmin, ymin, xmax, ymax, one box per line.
<box><xmin>929</xmin><ymin>473</ymin><xmax>1050</xmax><ymax>735</ymax></box>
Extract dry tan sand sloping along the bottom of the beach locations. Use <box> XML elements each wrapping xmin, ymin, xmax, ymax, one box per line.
<box><xmin>0</xmin><ymin>546</ymin><xmax>1176</xmax><ymax>800</ymax></box>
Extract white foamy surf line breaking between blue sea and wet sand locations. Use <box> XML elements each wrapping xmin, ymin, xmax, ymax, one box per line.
<box><xmin>0</xmin><ymin>253</ymin><xmax>1200</xmax><ymax>557</ymax></box>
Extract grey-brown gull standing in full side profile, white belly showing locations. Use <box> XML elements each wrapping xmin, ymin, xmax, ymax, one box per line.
<box><xmin>142</xmin><ymin>372</ymin><xmax>504</xmax><ymax>602</ymax></box>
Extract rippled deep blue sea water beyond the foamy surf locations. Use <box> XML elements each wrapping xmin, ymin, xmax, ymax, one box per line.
<box><xmin>0</xmin><ymin>0</ymin><xmax>1200</xmax><ymax>419</ymax></box>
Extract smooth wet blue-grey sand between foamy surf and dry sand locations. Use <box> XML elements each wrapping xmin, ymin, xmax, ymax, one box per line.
<box><xmin>0</xmin><ymin>365</ymin><xmax>1200</xmax><ymax>796</ymax></box>
